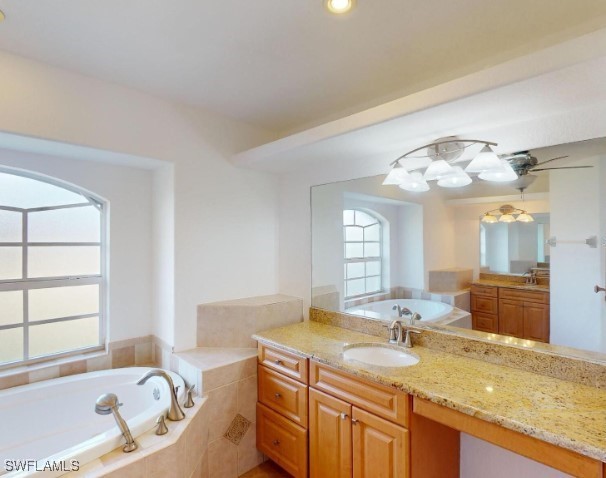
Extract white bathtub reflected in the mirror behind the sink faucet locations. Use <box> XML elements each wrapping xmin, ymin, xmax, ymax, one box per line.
<box><xmin>345</xmin><ymin>299</ymin><xmax>453</xmax><ymax>322</ymax></box>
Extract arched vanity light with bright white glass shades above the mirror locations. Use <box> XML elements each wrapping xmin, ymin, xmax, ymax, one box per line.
<box><xmin>383</xmin><ymin>136</ymin><xmax>518</xmax><ymax>191</ymax></box>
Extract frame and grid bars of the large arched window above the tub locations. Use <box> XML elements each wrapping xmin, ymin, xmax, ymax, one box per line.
<box><xmin>0</xmin><ymin>167</ymin><xmax>109</xmax><ymax>371</ymax></box>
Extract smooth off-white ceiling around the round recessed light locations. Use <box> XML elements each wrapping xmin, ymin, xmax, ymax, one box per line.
<box><xmin>0</xmin><ymin>0</ymin><xmax>606</xmax><ymax>135</ymax></box>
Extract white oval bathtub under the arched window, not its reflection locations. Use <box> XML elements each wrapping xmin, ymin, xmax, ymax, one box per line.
<box><xmin>0</xmin><ymin>367</ymin><xmax>184</xmax><ymax>478</ymax></box>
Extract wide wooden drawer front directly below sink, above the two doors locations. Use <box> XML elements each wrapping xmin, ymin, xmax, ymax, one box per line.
<box><xmin>310</xmin><ymin>360</ymin><xmax>409</xmax><ymax>427</ymax></box>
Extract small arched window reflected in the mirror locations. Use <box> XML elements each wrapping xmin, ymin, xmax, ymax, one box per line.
<box><xmin>343</xmin><ymin>209</ymin><xmax>383</xmax><ymax>299</ymax></box>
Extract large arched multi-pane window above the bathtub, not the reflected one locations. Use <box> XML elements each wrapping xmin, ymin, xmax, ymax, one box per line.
<box><xmin>0</xmin><ymin>169</ymin><xmax>105</xmax><ymax>367</ymax></box>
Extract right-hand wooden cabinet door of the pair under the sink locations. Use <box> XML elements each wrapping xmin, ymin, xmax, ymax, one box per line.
<box><xmin>352</xmin><ymin>407</ymin><xmax>410</xmax><ymax>478</ymax></box>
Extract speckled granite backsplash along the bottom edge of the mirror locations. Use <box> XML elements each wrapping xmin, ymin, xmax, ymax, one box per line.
<box><xmin>309</xmin><ymin>307</ymin><xmax>606</xmax><ymax>389</ymax></box>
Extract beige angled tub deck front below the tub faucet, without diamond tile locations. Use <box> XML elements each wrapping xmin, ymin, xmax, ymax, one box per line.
<box><xmin>69</xmin><ymin>398</ymin><xmax>210</xmax><ymax>478</ymax></box>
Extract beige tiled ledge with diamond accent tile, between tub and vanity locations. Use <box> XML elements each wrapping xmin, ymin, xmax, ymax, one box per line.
<box><xmin>173</xmin><ymin>342</ymin><xmax>264</xmax><ymax>478</ymax></box>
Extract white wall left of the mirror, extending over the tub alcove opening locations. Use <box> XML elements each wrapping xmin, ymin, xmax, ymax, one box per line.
<box><xmin>0</xmin><ymin>52</ymin><xmax>280</xmax><ymax>350</ymax></box>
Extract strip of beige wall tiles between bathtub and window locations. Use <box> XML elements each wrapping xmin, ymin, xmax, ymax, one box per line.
<box><xmin>0</xmin><ymin>335</ymin><xmax>164</xmax><ymax>390</ymax></box>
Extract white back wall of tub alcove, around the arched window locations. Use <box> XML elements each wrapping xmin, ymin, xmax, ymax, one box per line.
<box><xmin>0</xmin><ymin>150</ymin><xmax>152</xmax><ymax>341</ymax></box>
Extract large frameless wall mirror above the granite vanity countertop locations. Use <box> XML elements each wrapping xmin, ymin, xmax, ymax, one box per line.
<box><xmin>311</xmin><ymin>138</ymin><xmax>606</xmax><ymax>361</ymax></box>
